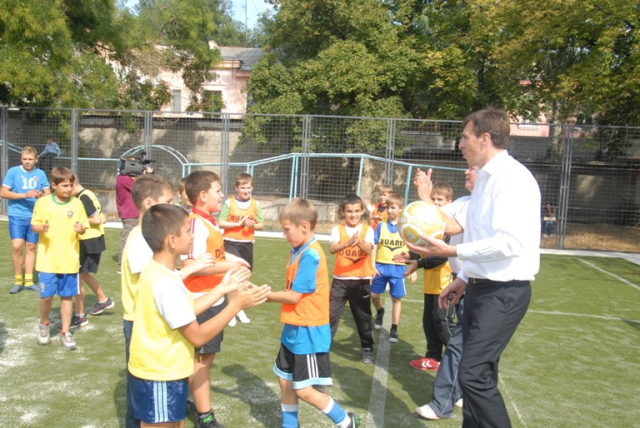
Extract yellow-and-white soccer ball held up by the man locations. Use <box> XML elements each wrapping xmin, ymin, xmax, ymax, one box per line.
<box><xmin>398</xmin><ymin>201</ymin><xmax>447</xmax><ymax>247</ymax></box>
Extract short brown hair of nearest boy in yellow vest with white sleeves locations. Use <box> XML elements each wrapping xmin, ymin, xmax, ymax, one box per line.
<box><xmin>142</xmin><ymin>204</ymin><xmax>189</xmax><ymax>253</ymax></box>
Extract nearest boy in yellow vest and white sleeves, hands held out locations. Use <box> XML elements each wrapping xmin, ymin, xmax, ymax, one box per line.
<box><xmin>128</xmin><ymin>204</ymin><xmax>270</xmax><ymax>428</ymax></box>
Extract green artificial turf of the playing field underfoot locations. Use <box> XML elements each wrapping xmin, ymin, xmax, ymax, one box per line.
<box><xmin>0</xmin><ymin>226</ymin><xmax>640</xmax><ymax>428</ymax></box>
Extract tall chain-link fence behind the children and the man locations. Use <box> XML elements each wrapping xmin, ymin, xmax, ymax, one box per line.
<box><xmin>0</xmin><ymin>107</ymin><xmax>640</xmax><ymax>251</ymax></box>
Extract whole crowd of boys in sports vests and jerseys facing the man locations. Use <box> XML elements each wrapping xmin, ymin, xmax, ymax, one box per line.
<box><xmin>1</xmin><ymin>147</ymin><xmax>464</xmax><ymax>428</ymax></box>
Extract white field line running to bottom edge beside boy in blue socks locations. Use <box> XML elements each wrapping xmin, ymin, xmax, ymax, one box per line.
<box><xmin>366</xmin><ymin>298</ymin><xmax>391</xmax><ymax>428</ymax></box>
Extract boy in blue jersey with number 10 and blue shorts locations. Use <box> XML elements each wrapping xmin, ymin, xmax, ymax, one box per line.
<box><xmin>0</xmin><ymin>146</ymin><xmax>50</xmax><ymax>294</ymax></box>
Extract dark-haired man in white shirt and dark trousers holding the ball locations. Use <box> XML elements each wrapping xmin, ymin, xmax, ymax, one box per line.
<box><xmin>408</xmin><ymin>108</ymin><xmax>540</xmax><ymax>428</ymax></box>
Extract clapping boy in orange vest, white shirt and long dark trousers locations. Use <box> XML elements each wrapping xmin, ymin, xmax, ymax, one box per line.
<box><xmin>329</xmin><ymin>194</ymin><xmax>373</xmax><ymax>364</ymax></box>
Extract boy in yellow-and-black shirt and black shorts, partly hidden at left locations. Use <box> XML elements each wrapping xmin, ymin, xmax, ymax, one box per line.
<box><xmin>70</xmin><ymin>175</ymin><xmax>115</xmax><ymax>329</ymax></box>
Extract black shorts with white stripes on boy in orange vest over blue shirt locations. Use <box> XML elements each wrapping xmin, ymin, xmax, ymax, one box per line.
<box><xmin>273</xmin><ymin>343</ymin><xmax>333</xmax><ymax>389</ymax></box>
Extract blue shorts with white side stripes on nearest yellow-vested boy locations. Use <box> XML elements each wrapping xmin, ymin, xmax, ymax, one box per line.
<box><xmin>129</xmin><ymin>374</ymin><xmax>189</xmax><ymax>424</ymax></box>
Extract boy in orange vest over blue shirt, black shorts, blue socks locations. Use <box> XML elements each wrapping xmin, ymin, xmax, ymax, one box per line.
<box><xmin>267</xmin><ymin>198</ymin><xmax>358</xmax><ymax>428</ymax></box>
